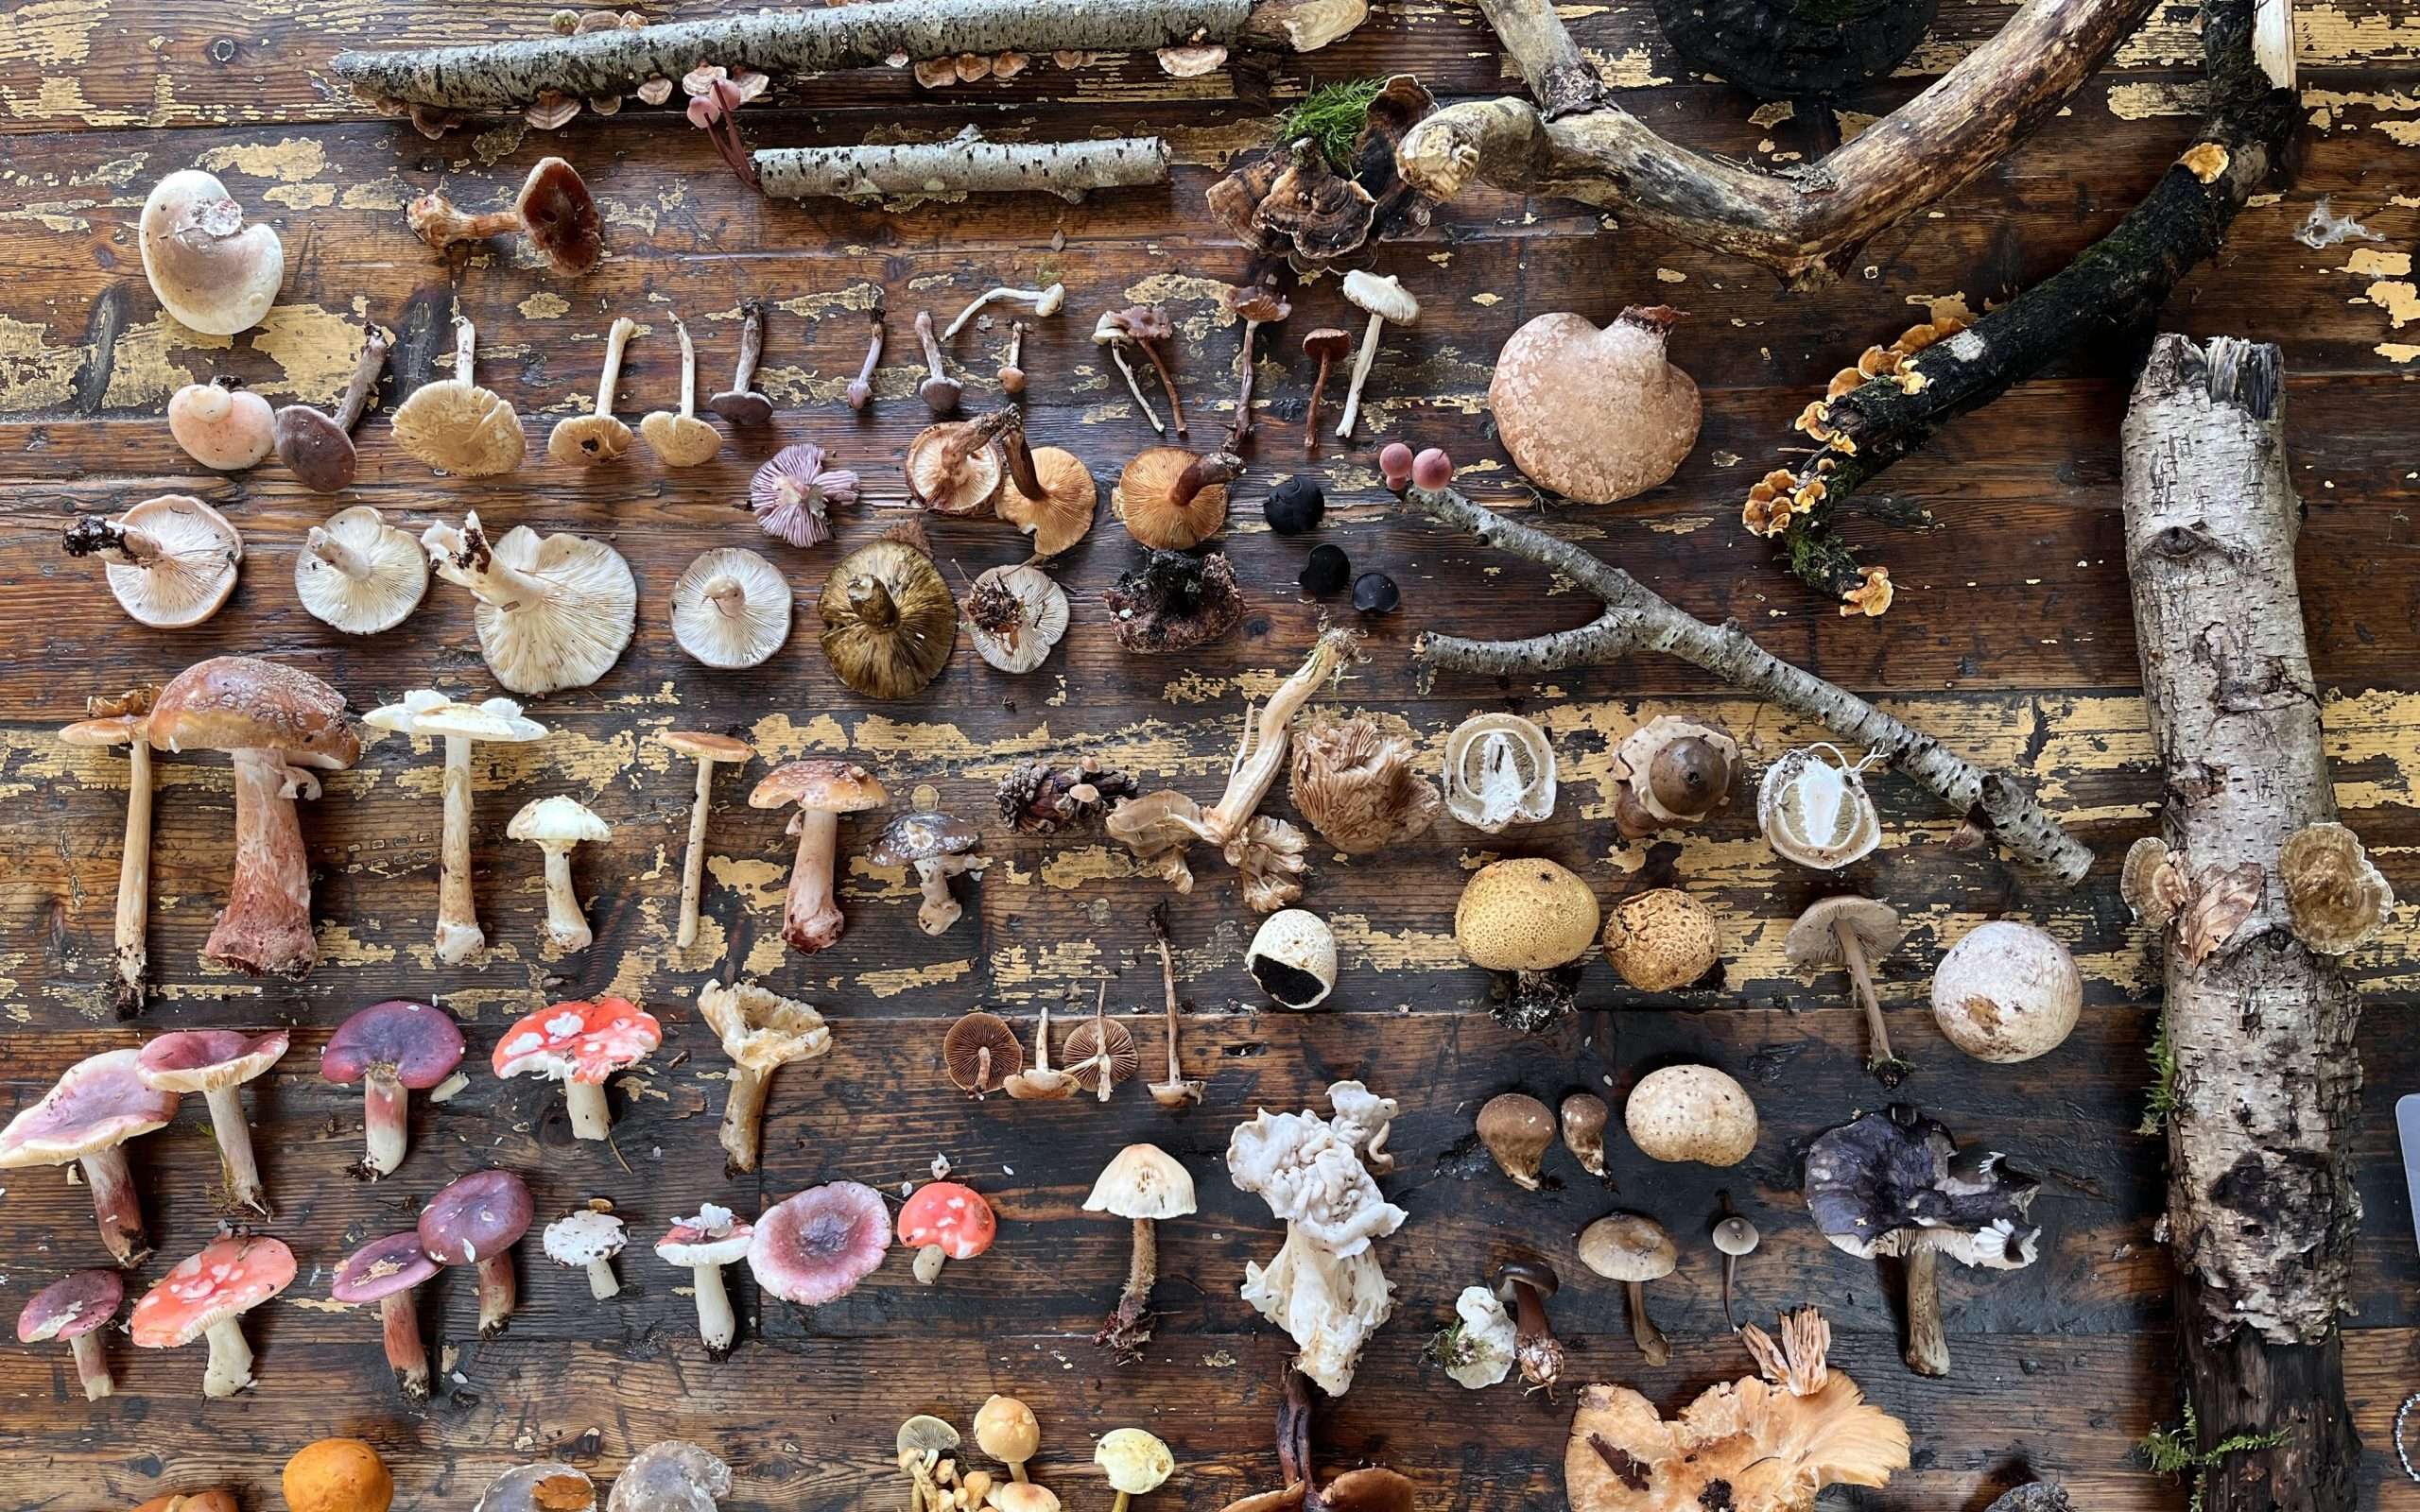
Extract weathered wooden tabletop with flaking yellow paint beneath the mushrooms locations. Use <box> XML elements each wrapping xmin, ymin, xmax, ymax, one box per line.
<box><xmin>0</xmin><ymin>0</ymin><xmax>2420</xmax><ymax>1512</ymax></box>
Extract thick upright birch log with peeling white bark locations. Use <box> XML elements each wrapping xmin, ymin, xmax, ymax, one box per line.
<box><xmin>2125</xmin><ymin>336</ymin><xmax>2362</xmax><ymax>1512</ymax></box>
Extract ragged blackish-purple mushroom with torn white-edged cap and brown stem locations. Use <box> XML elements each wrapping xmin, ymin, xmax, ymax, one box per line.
<box><xmin>1806</xmin><ymin>1103</ymin><xmax>2043</xmax><ymax>1377</ymax></box>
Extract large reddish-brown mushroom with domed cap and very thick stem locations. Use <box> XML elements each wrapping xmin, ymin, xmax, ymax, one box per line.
<box><xmin>146</xmin><ymin>656</ymin><xmax>360</xmax><ymax>977</ymax></box>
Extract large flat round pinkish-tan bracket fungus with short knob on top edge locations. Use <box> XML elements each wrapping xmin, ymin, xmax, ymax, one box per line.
<box><xmin>1488</xmin><ymin>305</ymin><xmax>1699</xmax><ymax>503</ymax></box>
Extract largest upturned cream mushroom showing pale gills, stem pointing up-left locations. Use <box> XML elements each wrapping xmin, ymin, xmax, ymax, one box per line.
<box><xmin>421</xmin><ymin>513</ymin><xmax>639</xmax><ymax>696</ymax></box>
